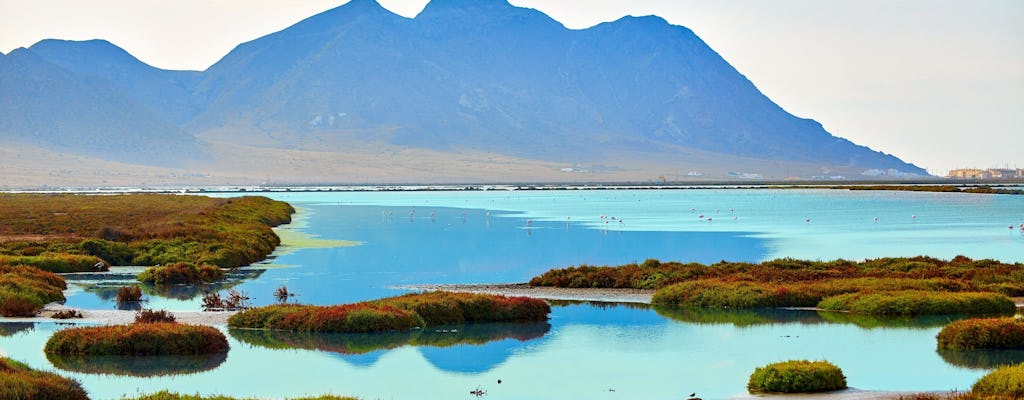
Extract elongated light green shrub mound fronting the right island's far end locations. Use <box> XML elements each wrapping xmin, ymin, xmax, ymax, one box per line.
<box><xmin>818</xmin><ymin>291</ymin><xmax>1017</xmax><ymax>315</ymax></box>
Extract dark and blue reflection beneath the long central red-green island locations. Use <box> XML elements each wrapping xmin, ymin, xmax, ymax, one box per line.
<box><xmin>228</xmin><ymin>322</ymin><xmax>551</xmax><ymax>372</ymax></box>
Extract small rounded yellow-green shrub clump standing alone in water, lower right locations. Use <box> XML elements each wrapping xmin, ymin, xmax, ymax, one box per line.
<box><xmin>746</xmin><ymin>360</ymin><xmax>846</xmax><ymax>393</ymax></box>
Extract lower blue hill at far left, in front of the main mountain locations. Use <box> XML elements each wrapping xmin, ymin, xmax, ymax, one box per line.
<box><xmin>0</xmin><ymin>48</ymin><xmax>203</xmax><ymax>168</ymax></box>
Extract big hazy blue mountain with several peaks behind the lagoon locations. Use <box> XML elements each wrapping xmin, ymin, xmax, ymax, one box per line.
<box><xmin>0</xmin><ymin>0</ymin><xmax>927</xmax><ymax>182</ymax></box>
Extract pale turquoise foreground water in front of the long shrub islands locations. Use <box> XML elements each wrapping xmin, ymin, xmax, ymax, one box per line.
<box><xmin>0</xmin><ymin>303</ymin><xmax>984</xmax><ymax>400</ymax></box>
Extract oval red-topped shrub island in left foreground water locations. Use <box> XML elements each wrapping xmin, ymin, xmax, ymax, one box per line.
<box><xmin>44</xmin><ymin>322</ymin><xmax>227</xmax><ymax>356</ymax></box>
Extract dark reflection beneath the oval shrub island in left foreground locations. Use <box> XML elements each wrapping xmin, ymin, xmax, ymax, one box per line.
<box><xmin>46</xmin><ymin>352</ymin><xmax>227</xmax><ymax>377</ymax></box>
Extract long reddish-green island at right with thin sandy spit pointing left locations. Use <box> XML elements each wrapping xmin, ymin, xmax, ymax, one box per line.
<box><xmin>428</xmin><ymin>256</ymin><xmax>1024</xmax><ymax>315</ymax></box>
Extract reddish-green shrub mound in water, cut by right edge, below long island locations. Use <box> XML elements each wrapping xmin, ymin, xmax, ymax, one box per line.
<box><xmin>936</xmin><ymin>317</ymin><xmax>1024</xmax><ymax>350</ymax></box>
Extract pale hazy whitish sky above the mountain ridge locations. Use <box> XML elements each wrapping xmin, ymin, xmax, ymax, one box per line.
<box><xmin>0</xmin><ymin>0</ymin><xmax>1024</xmax><ymax>174</ymax></box>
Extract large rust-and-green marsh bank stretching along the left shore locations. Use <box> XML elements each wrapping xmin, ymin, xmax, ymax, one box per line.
<box><xmin>0</xmin><ymin>193</ymin><xmax>295</xmax><ymax>317</ymax></box>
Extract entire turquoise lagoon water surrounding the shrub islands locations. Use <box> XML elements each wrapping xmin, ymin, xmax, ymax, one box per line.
<box><xmin>0</xmin><ymin>189</ymin><xmax>1024</xmax><ymax>399</ymax></box>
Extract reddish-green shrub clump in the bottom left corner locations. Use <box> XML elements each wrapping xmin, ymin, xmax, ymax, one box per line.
<box><xmin>0</xmin><ymin>357</ymin><xmax>89</xmax><ymax>400</ymax></box>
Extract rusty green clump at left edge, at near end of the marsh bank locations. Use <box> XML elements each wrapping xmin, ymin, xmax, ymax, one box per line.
<box><xmin>0</xmin><ymin>265</ymin><xmax>68</xmax><ymax>317</ymax></box>
